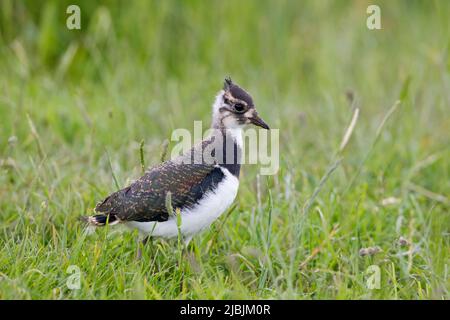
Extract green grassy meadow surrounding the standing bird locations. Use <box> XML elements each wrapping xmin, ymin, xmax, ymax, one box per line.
<box><xmin>0</xmin><ymin>0</ymin><xmax>450</xmax><ymax>299</ymax></box>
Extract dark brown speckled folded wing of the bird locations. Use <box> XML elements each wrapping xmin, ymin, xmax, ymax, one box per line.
<box><xmin>95</xmin><ymin>161</ymin><xmax>224</xmax><ymax>222</ymax></box>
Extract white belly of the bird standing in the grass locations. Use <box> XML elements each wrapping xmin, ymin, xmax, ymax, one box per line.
<box><xmin>126</xmin><ymin>168</ymin><xmax>239</xmax><ymax>239</ymax></box>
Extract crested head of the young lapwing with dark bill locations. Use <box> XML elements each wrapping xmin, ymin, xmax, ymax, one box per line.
<box><xmin>213</xmin><ymin>77</ymin><xmax>269</xmax><ymax>129</ymax></box>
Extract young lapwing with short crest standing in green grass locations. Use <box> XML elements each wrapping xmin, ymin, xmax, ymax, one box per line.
<box><xmin>82</xmin><ymin>77</ymin><xmax>269</xmax><ymax>255</ymax></box>
